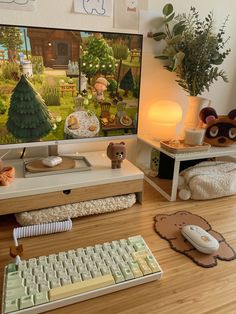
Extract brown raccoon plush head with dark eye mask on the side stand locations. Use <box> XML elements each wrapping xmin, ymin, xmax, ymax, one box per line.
<box><xmin>199</xmin><ymin>107</ymin><xmax>236</xmax><ymax>147</ymax></box>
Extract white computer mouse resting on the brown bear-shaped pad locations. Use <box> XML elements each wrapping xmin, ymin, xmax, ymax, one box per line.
<box><xmin>181</xmin><ymin>225</ymin><xmax>219</xmax><ymax>254</ymax></box>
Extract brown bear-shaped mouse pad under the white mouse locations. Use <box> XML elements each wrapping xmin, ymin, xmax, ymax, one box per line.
<box><xmin>154</xmin><ymin>211</ymin><xmax>236</xmax><ymax>267</ymax></box>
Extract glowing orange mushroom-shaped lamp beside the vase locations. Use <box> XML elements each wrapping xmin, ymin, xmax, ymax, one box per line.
<box><xmin>148</xmin><ymin>100</ymin><xmax>182</xmax><ymax>140</ymax></box>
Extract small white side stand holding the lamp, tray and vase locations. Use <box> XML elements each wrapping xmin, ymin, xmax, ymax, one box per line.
<box><xmin>137</xmin><ymin>136</ymin><xmax>236</xmax><ymax>201</ymax></box>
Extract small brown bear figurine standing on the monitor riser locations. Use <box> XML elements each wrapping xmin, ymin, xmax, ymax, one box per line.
<box><xmin>107</xmin><ymin>142</ymin><xmax>126</xmax><ymax>169</ymax></box>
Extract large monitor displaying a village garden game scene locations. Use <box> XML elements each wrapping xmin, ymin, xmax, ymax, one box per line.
<box><xmin>0</xmin><ymin>25</ymin><xmax>142</xmax><ymax>148</ymax></box>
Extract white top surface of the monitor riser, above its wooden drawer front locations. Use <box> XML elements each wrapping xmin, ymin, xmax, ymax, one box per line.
<box><xmin>0</xmin><ymin>152</ymin><xmax>144</xmax><ymax>200</ymax></box>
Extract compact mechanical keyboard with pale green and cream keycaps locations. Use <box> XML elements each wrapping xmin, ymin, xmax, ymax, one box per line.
<box><xmin>2</xmin><ymin>235</ymin><xmax>163</xmax><ymax>314</ymax></box>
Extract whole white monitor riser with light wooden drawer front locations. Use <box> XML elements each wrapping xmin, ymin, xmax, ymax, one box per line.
<box><xmin>0</xmin><ymin>152</ymin><xmax>144</xmax><ymax>215</ymax></box>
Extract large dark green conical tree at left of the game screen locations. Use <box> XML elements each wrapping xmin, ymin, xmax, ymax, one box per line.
<box><xmin>7</xmin><ymin>75</ymin><xmax>52</xmax><ymax>142</ymax></box>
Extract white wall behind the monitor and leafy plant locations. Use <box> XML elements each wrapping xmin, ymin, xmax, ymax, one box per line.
<box><xmin>0</xmin><ymin>0</ymin><xmax>236</xmax><ymax>159</ymax></box>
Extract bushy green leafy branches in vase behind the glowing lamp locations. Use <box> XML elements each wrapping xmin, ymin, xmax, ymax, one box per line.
<box><xmin>149</xmin><ymin>3</ymin><xmax>230</xmax><ymax>129</ymax></box>
